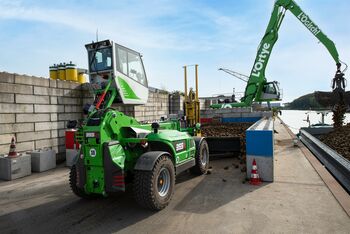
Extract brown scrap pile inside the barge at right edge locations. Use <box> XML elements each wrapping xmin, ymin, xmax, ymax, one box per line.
<box><xmin>320</xmin><ymin>123</ymin><xmax>350</xmax><ymax>160</ymax></box>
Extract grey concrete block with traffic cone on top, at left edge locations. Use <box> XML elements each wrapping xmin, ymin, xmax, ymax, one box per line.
<box><xmin>0</xmin><ymin>154</ymin><xmax>32</xmax><ymax>180</ymax></box>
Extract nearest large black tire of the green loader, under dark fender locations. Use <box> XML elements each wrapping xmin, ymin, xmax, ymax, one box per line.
<box><xmin>133</xmin><ymin>154</ymin><xmax>175</xmax><ymax>211</ymax></box>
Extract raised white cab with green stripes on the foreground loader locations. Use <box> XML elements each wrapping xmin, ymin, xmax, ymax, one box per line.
<box><xmin>85</xmin><ymin>40</ymin><xmax>148</xmax><ymax>105</ymax></box>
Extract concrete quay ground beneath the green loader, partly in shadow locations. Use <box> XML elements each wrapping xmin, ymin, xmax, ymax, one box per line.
<box><xmin>0</xmin><ymin>120</ymin><xmax>350</xmax><ymax>233</ymax></box>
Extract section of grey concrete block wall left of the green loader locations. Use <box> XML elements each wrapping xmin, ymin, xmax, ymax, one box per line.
<box><xmin>0</xmin><ymin>72</ymin><xmax>83</xmax><ymax>154</ymax></box>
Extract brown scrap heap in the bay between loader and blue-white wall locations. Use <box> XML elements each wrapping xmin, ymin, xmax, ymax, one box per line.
<box><xmin>201</xmin><ymin>123</ymin><xmax>252</xmax><ymax>160</ymax></box>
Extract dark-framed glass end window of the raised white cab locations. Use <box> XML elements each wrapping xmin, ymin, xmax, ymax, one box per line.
<box><xmin>89</xmin><ymin>47</ymin><xmax>112</xmax><ymax>72</ymax></box>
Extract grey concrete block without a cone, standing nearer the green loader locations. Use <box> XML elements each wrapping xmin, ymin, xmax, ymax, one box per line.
<box><xmin>31</xmin><ymin>149</ymin><xmax>56</xmax><ymax>172</ymax></box>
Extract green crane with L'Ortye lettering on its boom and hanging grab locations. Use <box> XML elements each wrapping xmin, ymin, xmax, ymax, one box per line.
<box><xmin>211</xmin><ymin>0</ymin><xmax>346</xmax><ymax>108</ymax></box>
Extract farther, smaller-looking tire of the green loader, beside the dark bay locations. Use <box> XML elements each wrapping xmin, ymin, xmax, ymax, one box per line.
<box><xmin>190</xmin><ymin>139</ymin><xmax>209</xmax><ymax>175</ymax></box>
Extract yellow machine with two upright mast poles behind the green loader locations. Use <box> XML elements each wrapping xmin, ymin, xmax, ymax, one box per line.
<box><xmin>184</xmin><ymin>64</ymin><xmax>200</xmax><ymax>135</ymax></box>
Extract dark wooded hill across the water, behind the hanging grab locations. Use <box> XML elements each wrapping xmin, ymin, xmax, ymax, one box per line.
<box><xmin>288</xmin><ymin>91</ymin><xmax>350</xmax><ymax>110</ymax></box>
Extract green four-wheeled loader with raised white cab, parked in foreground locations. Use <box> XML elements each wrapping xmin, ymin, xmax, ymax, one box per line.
<box><xmin>70</xmin><ymin>40</ymin><xmax>209</xmax><ymax>210</ymax></box>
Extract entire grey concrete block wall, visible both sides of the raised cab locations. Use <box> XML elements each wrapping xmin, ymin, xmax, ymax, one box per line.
<box><xmin>0</xmin><ymin>72</ymin><xmax>193</xmax><ymax>159</ymax></box>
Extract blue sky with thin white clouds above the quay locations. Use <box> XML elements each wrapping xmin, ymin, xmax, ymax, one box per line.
<box><xmin>0</xmin><ymin>0</ymin><xmax>350</xmax><ymax>102</ymax></box>
